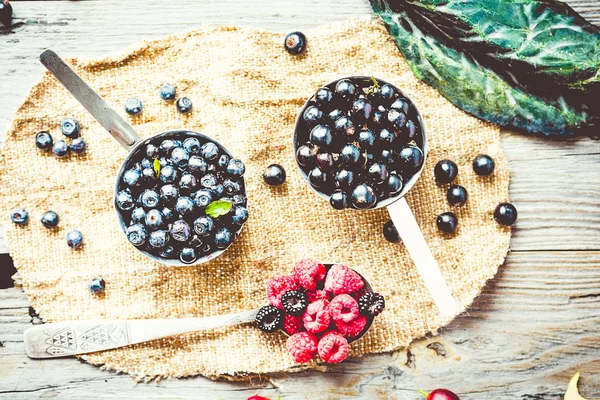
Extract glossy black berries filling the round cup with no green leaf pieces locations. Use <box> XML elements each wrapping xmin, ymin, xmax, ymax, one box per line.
<box><xmin>295</xmin><ymin>77</ymin><xmax>424</xmax><ymax>209</ymax></box>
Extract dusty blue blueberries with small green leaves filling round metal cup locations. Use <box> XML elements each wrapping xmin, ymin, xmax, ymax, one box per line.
<box><xmin>115</xmin><ymin>132</ymin><xmax>248</xmax><ymax>264</ymax></box>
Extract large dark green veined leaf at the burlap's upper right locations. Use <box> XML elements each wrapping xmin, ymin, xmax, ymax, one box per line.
<box><xmin>371</xmin><ymin>0</ymin><xmax>600</xmax><ymax>135</ymax></box>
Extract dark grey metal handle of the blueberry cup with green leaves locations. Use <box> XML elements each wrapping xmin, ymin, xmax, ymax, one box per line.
<box><xmin>40</xmin><ymin>50</ymin><xmax>142</xmax><ymax>151</ymax></box>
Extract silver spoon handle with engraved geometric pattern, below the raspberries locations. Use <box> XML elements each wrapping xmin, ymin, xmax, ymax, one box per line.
<box><xmin>25</xmin><ymin>308</ymin><xmax>259</xmax><ymax>358</ymax></box>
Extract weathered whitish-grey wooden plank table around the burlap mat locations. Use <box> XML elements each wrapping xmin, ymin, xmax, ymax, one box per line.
<box><xmin>0</xmin><ymin>0</ymin><xmax>600</xmax><ymax>400</ymax></box>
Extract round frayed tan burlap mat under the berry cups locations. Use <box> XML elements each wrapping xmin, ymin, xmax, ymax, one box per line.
<box><xmin>0</xmin><ymin>20</ymin><xmax>510</xmax><ymax>378</ymax></box>
